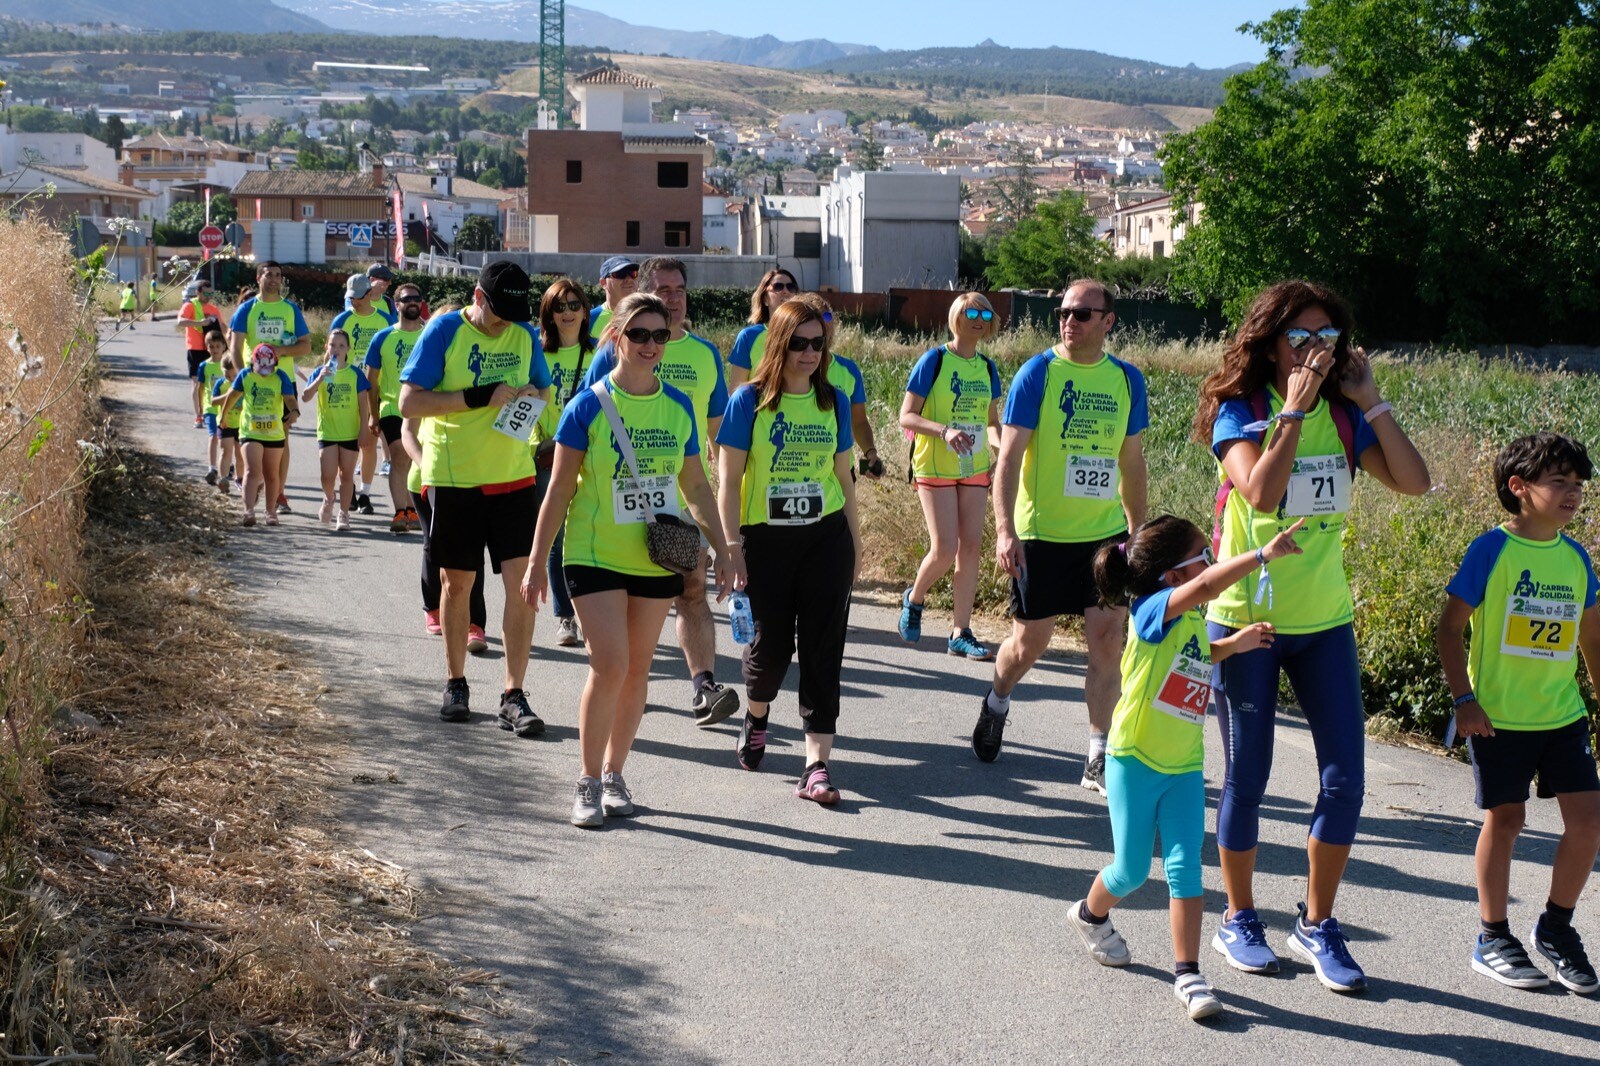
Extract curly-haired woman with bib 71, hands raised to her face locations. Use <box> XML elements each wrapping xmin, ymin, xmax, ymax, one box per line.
<box><xmin>1194</xmin><ymin>282</ymin><xmax>1429</xmax><ymax>992</ymax></box>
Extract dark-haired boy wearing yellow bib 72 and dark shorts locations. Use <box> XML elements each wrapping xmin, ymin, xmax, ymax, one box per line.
<box><xmin>1437</xmin><ymin>432</ymin><xmax>1600</xmax><ymax>996</ymax></box>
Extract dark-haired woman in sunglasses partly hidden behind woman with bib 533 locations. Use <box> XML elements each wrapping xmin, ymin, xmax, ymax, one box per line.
<box><xmin>533</xmin><ymin>277</ymin><xmax>595</xmax><ymax>648</ymax></box>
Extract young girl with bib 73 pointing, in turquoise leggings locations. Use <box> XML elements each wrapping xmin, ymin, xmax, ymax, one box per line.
<box><xmin>1067</xmin><ymin>515</ymin><xmax>1306</xmax><ymax>1020</ymax></box>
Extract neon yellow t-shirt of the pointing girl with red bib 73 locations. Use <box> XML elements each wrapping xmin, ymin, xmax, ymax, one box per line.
<box><xmin>1106</xmin><ymin>589</ymin><xmax>1211</xmax><ymax>773</ymax></box>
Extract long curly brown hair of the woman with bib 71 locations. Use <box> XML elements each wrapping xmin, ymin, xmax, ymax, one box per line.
<box><xmin>1194</xmin><ymin>280</ymin><xmax>1354</xmax><ymax>445</ymax></box>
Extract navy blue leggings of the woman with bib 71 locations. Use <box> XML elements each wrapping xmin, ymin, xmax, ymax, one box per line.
<box><xmin>1206</xmin><ymin>623</ymin><xmax>1366</xmax><ymax>852</ymax></box>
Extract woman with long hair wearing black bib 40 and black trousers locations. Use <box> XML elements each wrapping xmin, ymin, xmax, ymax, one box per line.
<box><xmin>717</xmin><ymin>299</ymin><xmax>861</xmax><ymax>804</ymax></box>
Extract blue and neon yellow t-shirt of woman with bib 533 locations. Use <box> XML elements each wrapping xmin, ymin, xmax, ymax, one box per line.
<box><xmin>555</xmin><ymin>378</ymin><xmax>699</xmax><ymax>576</ymax></box>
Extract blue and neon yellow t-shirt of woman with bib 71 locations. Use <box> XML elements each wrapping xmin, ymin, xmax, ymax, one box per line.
<box><xmin>1206</xmin><ymin>389</ymin><xmax>1378</xmax><ymax>632</ymax></box>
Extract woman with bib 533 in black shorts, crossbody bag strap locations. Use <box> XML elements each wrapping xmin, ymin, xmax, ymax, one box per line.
<box><xmin>522</xmin><ymin>293</ymin><xmax>744</xmax><ymax>828</ymax></box>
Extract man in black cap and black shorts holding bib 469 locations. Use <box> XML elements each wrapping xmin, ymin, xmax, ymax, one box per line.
<box><xmin>400</xmin><ymin>261</ymin><xmax>550</xmax><ymax>736</ymax></box>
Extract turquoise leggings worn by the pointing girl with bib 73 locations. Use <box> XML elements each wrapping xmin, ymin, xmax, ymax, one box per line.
<box><xmin>1101</xmin><ymin>755</ymin><xmax>1205</xmax><ymax>900</ymax></box>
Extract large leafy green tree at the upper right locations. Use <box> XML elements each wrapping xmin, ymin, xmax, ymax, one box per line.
<box><xmin>1163</xmin><ymin>0</ymin><xmax>1600</xmax><ymax>343</ymax></box>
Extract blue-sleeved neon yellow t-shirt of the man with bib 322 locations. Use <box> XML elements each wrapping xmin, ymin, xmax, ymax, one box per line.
<box><xmin>1003</xmin><ymin>349</ymin><xmax>1150</xmax><ymax>544</ymax></box>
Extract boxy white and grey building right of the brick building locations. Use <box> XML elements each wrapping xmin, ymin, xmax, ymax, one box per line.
<box><xmin>821</xmin><ymin>166</ymin><xmax>962</xmax><ymax>293</ymax></box>
